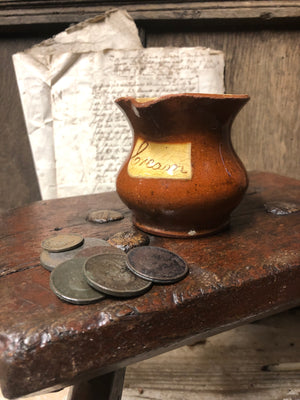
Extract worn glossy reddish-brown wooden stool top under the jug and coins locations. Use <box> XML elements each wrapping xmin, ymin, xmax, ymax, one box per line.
<box><xmin>0</xmin><ymin>173</ymin><xmax>300</xmax><ymax>398</ymax></box>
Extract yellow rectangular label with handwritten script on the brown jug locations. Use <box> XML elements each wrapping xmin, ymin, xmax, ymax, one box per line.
<box><xmin>128</xmin><ymin>138</ymin><xmax>192</xmax><ymax>179</ymax></box>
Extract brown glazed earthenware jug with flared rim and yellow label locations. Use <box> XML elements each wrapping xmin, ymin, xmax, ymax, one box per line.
<box><xmin>116</xmin><ymin>93</ymin><xmax>249</xmax><ymax>237</ymax></box>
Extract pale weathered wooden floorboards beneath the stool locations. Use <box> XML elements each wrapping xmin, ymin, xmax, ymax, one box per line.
<box><xmin>0</xmin><ymin>308</ymin><xmax>300</xmax><ymax>400</ymax></box>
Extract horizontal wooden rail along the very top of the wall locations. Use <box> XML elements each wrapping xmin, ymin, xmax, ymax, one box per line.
<box><xmin>0</xmin><ymin>0</ymin><xmax>300</xmax><ymax>26</ymax></box>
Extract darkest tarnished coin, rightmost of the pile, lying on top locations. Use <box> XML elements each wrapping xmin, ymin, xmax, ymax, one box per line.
<box><xmin>127</xmin><ymin>246</ymin><xmax>188</xmax><ymax>283</ymax></box>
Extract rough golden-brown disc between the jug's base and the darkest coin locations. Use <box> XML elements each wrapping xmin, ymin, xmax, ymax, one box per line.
<box><xmin>108</xmin><ymin>230</ymin><xmax>150</xmax><ymax>252</ymax></box>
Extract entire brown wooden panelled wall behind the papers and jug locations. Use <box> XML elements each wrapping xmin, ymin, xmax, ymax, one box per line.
<box><xmin>0</xmin><ymin>0</ymin><xmax>300</xmax><ymax>209</ymax></box>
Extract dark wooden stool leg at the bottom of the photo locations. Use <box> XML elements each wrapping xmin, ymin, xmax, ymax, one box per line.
<box><xmin>68</xmin><ymin>368</ymin><xmax>126</xmax><ymax>400</ymax></box>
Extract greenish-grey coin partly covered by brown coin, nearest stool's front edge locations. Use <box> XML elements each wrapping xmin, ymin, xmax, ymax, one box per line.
<box><xmin>50</xmin><ymin>258</ymin><xmax>105</xmax><ymax>304</ymax></box>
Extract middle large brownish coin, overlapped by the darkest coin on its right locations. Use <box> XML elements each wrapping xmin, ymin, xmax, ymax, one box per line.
<box><xmin>84</xmin><ymin>254</ymin><xmax>151</xmax><ymax>297</ymax></box>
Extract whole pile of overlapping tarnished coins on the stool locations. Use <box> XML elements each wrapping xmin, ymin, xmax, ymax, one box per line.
<box><xmin>40</xmin><ymin>235</ymin><xmax>188</xmax><ymax>304</ymax></box>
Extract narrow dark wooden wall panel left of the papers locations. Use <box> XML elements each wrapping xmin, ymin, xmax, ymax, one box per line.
<box><xmin>0</xmin><ymin>36</ymin><xmax>40</xmax><ymax>209</ymax></box>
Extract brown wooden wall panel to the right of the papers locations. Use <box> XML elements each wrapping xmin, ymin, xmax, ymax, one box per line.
<box><xmin>147</xmin><ymin>30</ymin><xmax>300</xmax><ymax>178</ymax></box>
